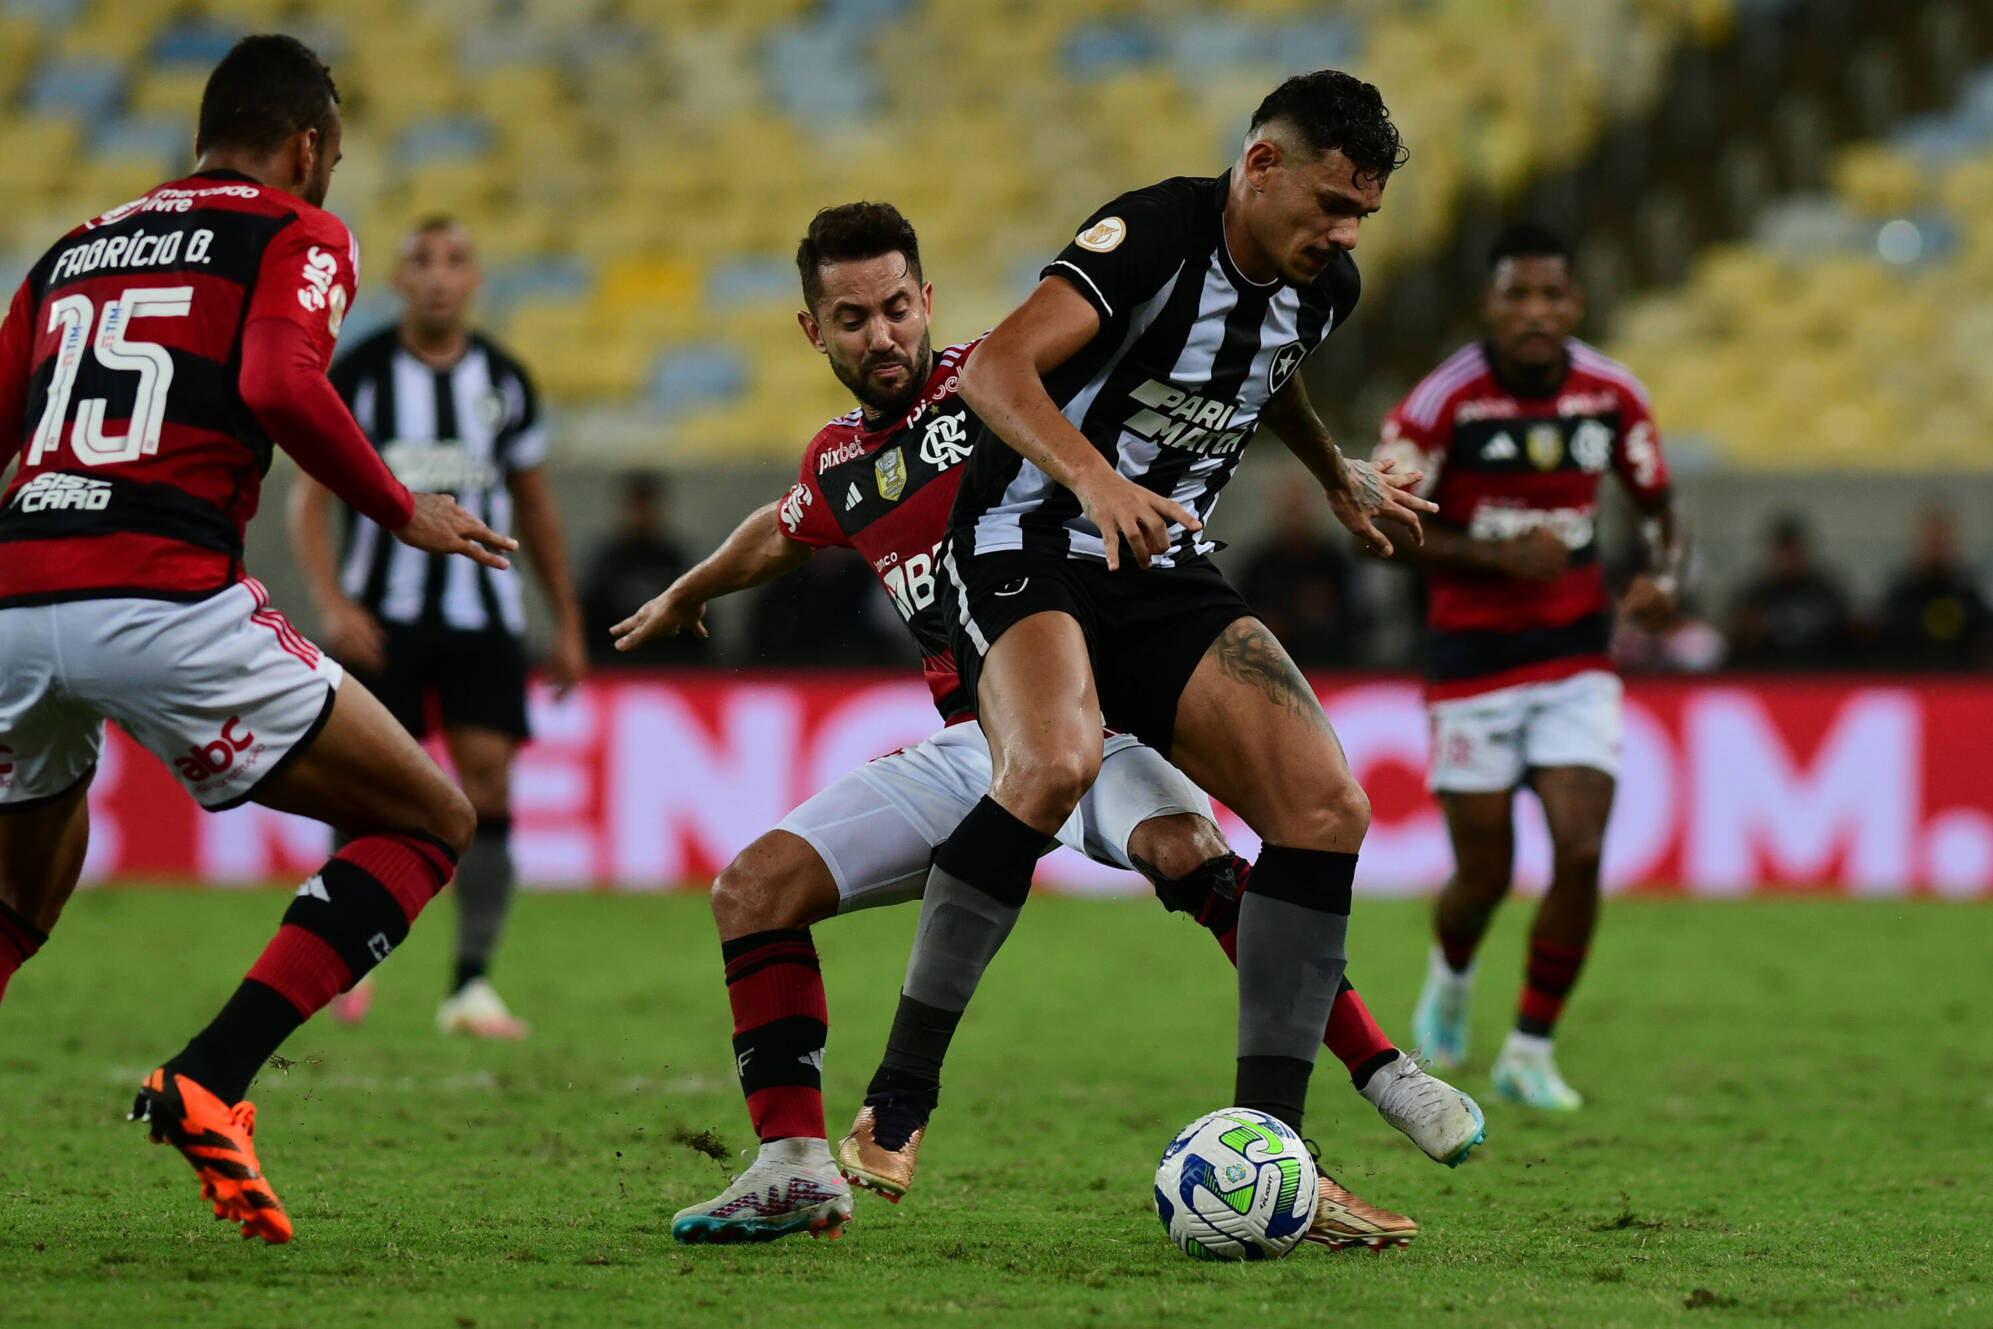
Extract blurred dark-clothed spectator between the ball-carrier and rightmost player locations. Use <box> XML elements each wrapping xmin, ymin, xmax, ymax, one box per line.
<box><xmin>1240</xmin><ymin>482</ymin><xmax>1367</xmax><ymax>667</ymax></box>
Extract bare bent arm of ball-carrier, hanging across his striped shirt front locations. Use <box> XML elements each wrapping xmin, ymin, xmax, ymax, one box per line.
<box><xmin>961</xmin><ymin>277</ymin><xmax>1204</xmax><ymax>568</ymax></box>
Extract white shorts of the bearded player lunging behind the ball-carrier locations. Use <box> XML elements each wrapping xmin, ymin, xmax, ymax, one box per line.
<box><xmin>777</xmin><ymin>723</ymin><xmax>1212</xmax><ymax>913</ymax></box>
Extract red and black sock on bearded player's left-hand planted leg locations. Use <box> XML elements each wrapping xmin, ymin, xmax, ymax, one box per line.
<box><xmin>719</xmin><ymin>929</ymin><xmax>831</xmax><ymax>1140</ymax></box>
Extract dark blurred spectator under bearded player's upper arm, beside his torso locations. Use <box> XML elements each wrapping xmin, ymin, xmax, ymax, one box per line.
<box><xmin>747</xmin><ymin>550</ymin><xmax>913</xmax><ymax>665</ymax></box>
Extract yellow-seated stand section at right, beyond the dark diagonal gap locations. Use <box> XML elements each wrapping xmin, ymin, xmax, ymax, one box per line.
<box><xmin>1614</xmin><ymin>68</ymin><xmax>1993</xmax><ymax>470</ymax></box>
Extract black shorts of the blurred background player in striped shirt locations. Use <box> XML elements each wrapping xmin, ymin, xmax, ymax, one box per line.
<box><xmin>351</xmin><ymin>622</ymin><xmax>528</xmax><ymax>741</ymax></box>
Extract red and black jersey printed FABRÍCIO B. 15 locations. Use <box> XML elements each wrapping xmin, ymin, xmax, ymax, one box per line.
<box><xmin>0</xmin><ymin>171</ymin><xmax>359</xmax><ymax>604</ymax></box>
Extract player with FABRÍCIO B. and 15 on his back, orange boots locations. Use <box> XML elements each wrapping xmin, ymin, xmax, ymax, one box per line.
<box><xmin>0</xmin><ymin>36</ymin><xmax>518</xmax><ymax>1241</ymax></box>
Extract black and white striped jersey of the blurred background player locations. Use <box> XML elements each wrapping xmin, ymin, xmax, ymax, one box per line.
<box><xmin>331</xmin><ymin>329</ymin><xmax>546</xmax><ymax>636</ymax></box>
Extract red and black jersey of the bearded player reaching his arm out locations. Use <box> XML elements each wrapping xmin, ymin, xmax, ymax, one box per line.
<box><xmin>779</xmin><ymin>339</ymin><xmax>981</xmax><ymax>723</ymax></box>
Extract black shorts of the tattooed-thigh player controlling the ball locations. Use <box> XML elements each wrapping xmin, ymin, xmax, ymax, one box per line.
<box><xmin>953</xmin><ymin>550</ymin><xmax>1252</xmax><ymax>755</ymax></box>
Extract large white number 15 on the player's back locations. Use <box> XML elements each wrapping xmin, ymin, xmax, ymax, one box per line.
<box><xmin>28</xmin><ymin>287</ymin><xmax>193</xmax><ymax>466</ymax></box>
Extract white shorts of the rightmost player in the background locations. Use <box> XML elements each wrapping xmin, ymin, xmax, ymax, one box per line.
<box><xmin>1427</xmin><ymin>669</ymin><xmax>1624</xmax><ymax>793</ymax></box>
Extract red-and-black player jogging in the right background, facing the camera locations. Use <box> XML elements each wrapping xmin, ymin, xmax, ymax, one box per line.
<box><xmin>1377</xmin><ymin>223</ymin><xmax>1684</xmax><ymax>1110</ymax></box>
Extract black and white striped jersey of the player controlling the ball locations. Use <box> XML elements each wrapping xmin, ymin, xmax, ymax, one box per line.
<box><xmin>951</xmin><ymin>173</ymin><xmax>1357</xmax><ymax>568</ymax></box>
